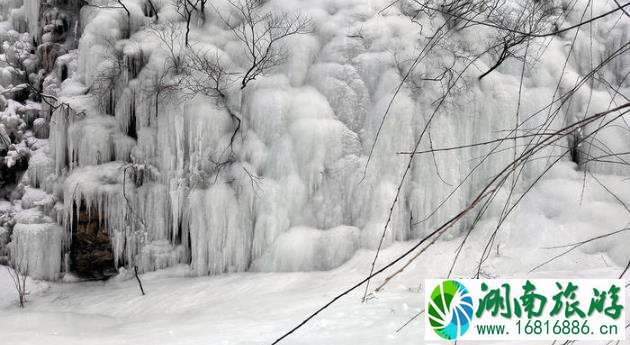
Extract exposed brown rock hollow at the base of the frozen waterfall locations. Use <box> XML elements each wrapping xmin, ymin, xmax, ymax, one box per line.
<box><xmin>70</xmin><ymin>210</ymin><xmax>117</xmax><ymax>279</ymax></box>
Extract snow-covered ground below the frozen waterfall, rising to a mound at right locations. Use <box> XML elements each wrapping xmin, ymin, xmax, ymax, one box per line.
<box><xmin>0</xmin><ymin>163</ymin><xmax>630</xmax><ymax>345</ymax></box>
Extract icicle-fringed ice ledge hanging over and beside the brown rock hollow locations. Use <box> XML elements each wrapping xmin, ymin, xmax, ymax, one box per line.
<box><xmin>63</xmin><ymin>162</ymin><xmax>186</xmax><ymax>271</ymax></box>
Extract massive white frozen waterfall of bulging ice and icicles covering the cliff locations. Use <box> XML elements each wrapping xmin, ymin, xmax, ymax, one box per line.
<box><xmin>0</xmin><ymin>0</ymin><xmax>630</xmax><ymax>279</ymax></box>
